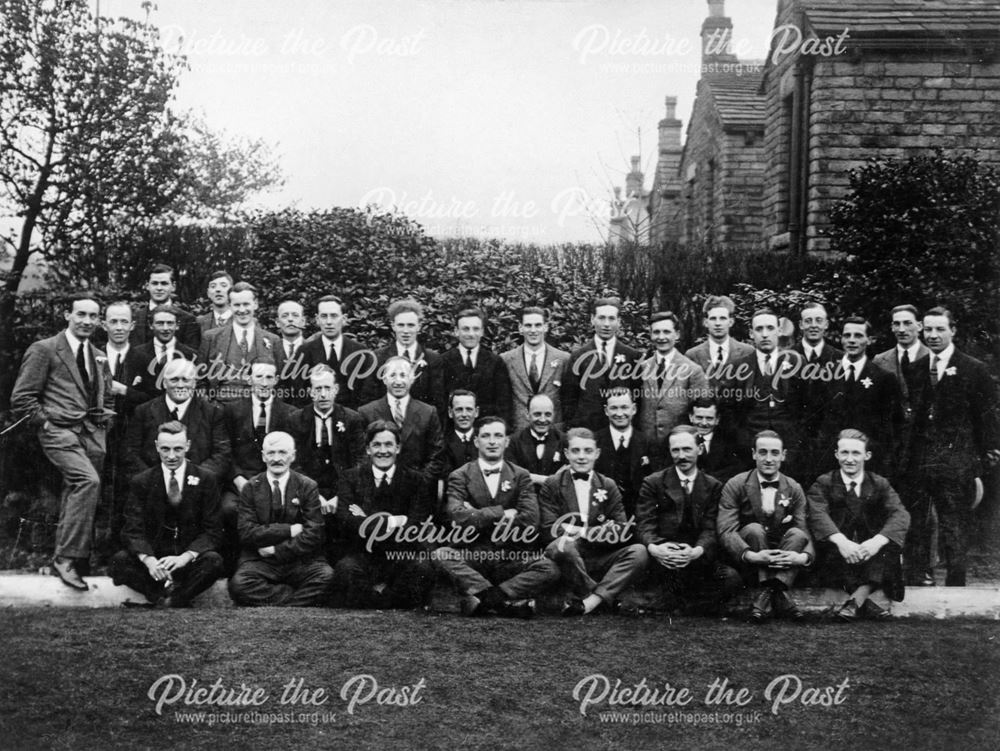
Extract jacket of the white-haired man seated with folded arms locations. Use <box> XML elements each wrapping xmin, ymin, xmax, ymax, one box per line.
<box><xmin>237</xmin><ymin>471</ymin><xmax>326</xmax><ymax>563</ymax></box>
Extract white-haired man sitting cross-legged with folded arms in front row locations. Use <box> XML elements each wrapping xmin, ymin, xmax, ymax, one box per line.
<box><xmin>229</xmin><ymin>431</ymin><xmax>333</xmax><ymax>607</ymax></box>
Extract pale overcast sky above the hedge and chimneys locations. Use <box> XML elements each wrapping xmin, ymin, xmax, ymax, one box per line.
<box><xmin>101</xmin><ymin>0</ymin><xmax>777</xmax><ymax>244</ymax></box>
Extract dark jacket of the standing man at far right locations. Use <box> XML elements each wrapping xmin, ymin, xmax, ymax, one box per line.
<box><xmin>912</xmin><ymin>349</ymin><xmax>1000</xmax><ymax>482</ymax></box>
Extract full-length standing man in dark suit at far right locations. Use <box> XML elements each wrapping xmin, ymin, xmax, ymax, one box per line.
<box><xmin>905</xmin><ymin>308</ymin><xmax>1000</xmax><ymax>587</ymax></box>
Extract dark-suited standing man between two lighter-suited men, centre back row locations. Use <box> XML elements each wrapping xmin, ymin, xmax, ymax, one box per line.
<box><xmin>561</xmin><ymin>297</ymin><xmax>640</xmax><ymax>431</ymax></box>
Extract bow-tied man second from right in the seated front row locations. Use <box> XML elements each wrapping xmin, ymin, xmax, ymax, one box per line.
<box><xmin>716</xmin><ymin>430</ymin><xmax>813</xmax><ymax>623</ymax></box>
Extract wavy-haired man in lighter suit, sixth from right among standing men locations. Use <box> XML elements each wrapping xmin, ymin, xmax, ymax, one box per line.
<box><xmin>684</xmin><ymin>295</ymin><xmax>753</xmax><ymax>423</ymax></box>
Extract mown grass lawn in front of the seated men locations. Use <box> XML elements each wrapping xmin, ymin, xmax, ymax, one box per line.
<box><xmin>0</xmin><ymin>609</ymin><xmax>1000</xmax><ymax>750</ymax></box>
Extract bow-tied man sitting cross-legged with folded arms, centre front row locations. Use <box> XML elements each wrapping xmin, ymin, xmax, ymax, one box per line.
<box><xmin>431</xmin><ymin>417</ymin><xmax>559</xmax><ymax>618</ymax></box>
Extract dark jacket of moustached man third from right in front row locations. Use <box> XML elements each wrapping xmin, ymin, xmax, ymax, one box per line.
<box><xmin>635</xmin><ymin>467</ymin><xmax>722</xmax><ymax>561</ymax></box>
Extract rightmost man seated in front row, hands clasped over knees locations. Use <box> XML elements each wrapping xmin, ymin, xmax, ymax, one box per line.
<box><xmin>807</xmin><ymin>429</ymin><xmax>910</xmax><ymax>622</ymax></box>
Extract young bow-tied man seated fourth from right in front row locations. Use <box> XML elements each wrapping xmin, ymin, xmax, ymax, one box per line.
<box><xmin>538</xmin><ymin>428</ymin><xmax>648</xmax><ymax>616</ymax></box>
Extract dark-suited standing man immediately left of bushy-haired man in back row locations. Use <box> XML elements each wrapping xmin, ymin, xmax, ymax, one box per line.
<box><xmin>300</xmin><ymin>295</ymin><xmax>375</xmax><ymax>409</ymax></box>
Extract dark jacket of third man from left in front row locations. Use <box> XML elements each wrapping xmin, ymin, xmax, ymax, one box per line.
<box><xmin>337</xmin><ymin>463</ymin><xmax>433</xmax><ymax>553</ymax></box>
